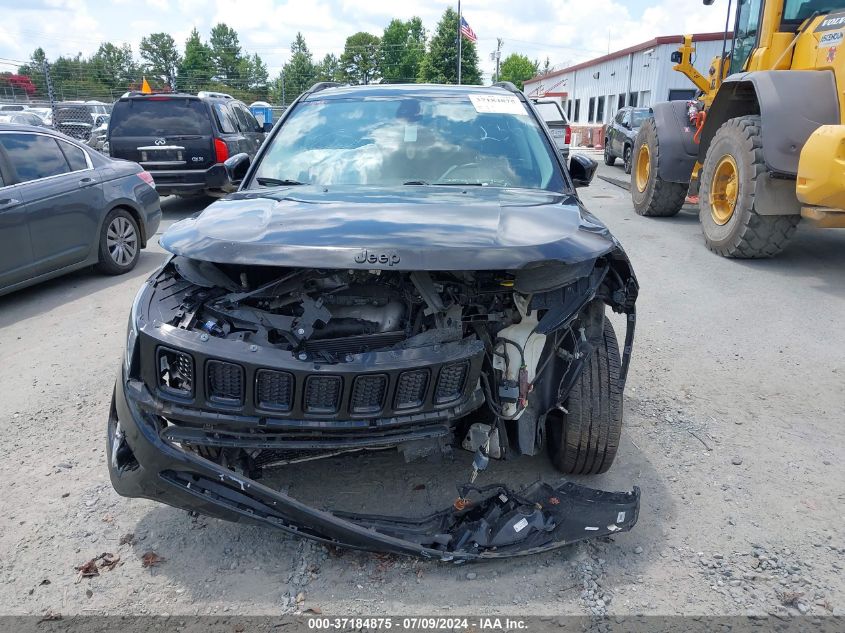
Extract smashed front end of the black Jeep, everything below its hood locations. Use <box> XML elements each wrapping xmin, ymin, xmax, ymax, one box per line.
<box><xmin>110</xmin><ymin>253</ymin><xmax>639</xmax><ymax>558</ymax></box>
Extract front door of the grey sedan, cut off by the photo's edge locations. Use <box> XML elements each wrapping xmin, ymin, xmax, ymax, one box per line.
<box><xmin>0</xmin><ymin>145</ymin><xmax>35</xmax><ymax>290</ymax></box>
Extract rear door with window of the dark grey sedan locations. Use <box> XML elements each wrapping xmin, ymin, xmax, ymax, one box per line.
<box><xmin>0</xmin><ymin>132</ymin><xmax>105</xmax><ymax>275</ymax></box>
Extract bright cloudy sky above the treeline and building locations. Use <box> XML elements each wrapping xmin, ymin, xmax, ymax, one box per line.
<box><xmin>0</xmin><ymin>0</ymin><xmax>727</xmax><ymax>80</ymax></box>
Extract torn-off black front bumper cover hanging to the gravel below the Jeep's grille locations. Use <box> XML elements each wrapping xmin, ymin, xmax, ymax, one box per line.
<box><xmin>107</xmin><ymin>374</ymin><xmax>640</xmax><ymax>560</ymax></box>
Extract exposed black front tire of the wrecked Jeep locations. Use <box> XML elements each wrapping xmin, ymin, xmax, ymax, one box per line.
<box><xmin>546</xmin><ymin>320</ymin><xmax>622</xmax><ymax>475</ymax></box>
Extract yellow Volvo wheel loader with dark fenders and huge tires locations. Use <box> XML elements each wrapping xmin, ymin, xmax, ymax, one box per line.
<box><xmin>631</xmin><ymin>0</ymin><xmax>845</xmax><ymax>258</ymax></box>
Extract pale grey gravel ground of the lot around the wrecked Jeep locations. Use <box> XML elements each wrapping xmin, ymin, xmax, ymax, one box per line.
<box><xmin>0</xmin><ymin>158</ymin><xmax>845</xmax><ymax>618</ymax></box>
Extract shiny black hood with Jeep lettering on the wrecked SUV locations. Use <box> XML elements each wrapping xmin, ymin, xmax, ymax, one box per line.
<box><xmin>160</xmin><ymin>185</ymin><xmax>618</xmax><ymax>270</ymax></box>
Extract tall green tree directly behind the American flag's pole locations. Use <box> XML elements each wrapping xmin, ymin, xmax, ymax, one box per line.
<box><xmin>419</xmin><ymin>7</ymin><xmax>481</xmax><ymax>84</ymax></box>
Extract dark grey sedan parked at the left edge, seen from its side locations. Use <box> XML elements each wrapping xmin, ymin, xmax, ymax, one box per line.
<box><xmin>0</xmin><ymin>124</ymin><xmax>161</xmax><ymax>294</ymax></box>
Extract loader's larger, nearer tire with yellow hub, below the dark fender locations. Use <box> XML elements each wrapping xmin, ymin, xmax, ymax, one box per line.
<box><xmin>698</xmin><ymin>115</ymin><xmax>801</xmax><ymax>259</ymax></box>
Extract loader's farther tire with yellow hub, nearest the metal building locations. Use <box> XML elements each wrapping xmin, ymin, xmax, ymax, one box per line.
<box><xmin>631</xmin><ymin>117</ymin><xmax>689</xmax><ymax>217</ymax></box>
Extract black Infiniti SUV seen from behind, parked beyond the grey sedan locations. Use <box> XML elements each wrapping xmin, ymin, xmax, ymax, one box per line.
<box><xmin>108</xmin><ymin>92</ymin><xmax>265</xmax><ymax>196</ymax></box>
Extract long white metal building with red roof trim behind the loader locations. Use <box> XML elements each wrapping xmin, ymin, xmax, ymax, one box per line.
<box><xmin>525</xmin><ymin>33</ymin><xmax>730</xmax><ymax>126</ymax></box>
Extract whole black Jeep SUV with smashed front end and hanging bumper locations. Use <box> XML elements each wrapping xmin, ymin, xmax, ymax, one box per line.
<box><xmin>108</xmin><ymin>84</ymin><xmax>639</xmax><ymax>560</ymax></box>
